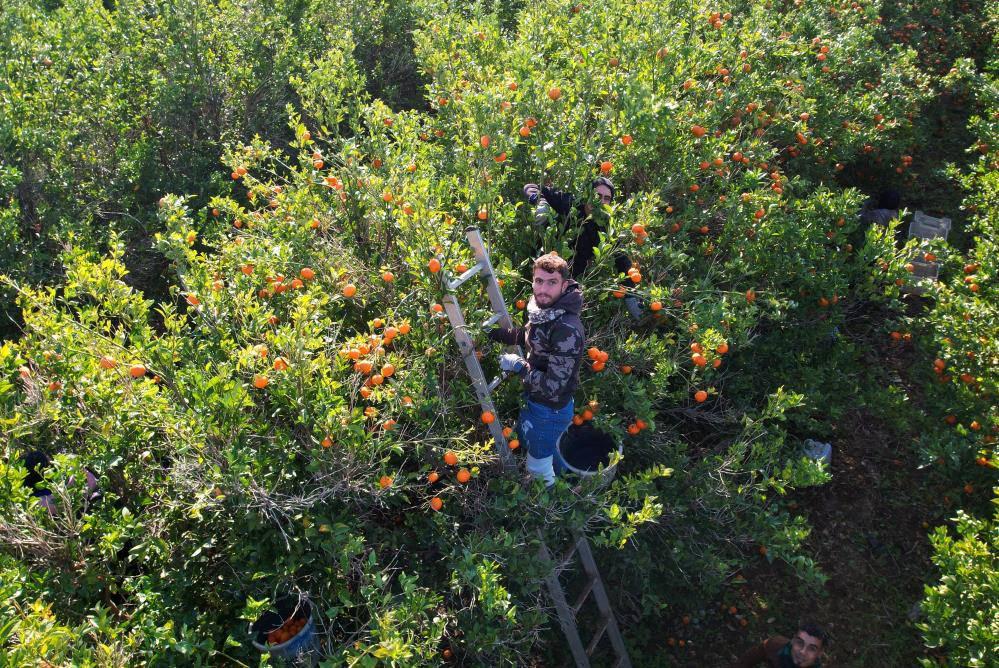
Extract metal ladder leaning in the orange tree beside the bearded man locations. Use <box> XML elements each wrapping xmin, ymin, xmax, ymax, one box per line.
<box><xmin>443</xmin><ymin>227</ymin><xmax>631</xmax><ymax>668</ymax></box>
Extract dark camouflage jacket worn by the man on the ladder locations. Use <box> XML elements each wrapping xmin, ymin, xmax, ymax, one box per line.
<box><xmin>497</xmin><ymin>281</ymin><xmax>586</xmax><ymax>408</ymax></box>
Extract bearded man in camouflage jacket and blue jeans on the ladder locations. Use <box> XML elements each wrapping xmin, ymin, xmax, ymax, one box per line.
<box><xmin>489</xmin><ymin>253</ymin><xmax>586</xmax><ymax>485</ymax></box>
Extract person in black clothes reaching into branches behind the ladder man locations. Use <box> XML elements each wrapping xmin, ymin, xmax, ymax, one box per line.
<box><xmin>524</xmin><ymin>176</ymin><xmax>642</xmax><ymax>320</ymax></box>
